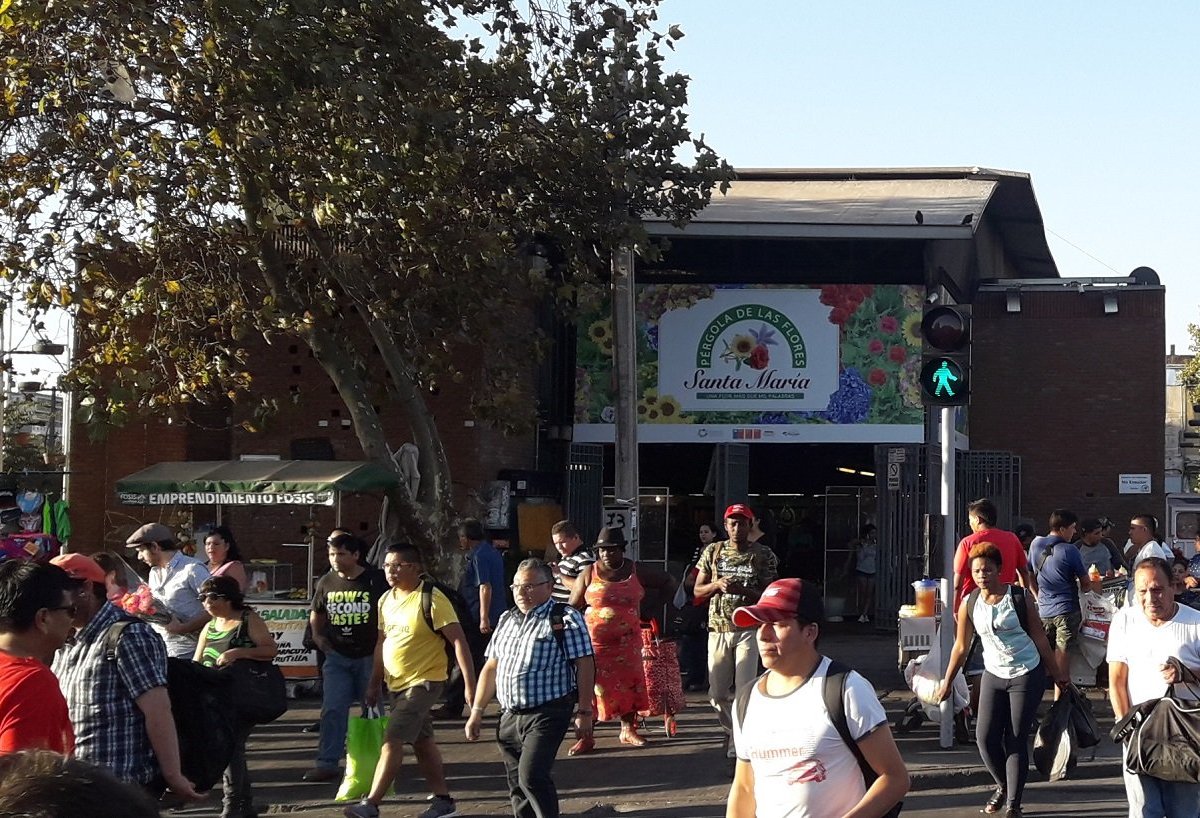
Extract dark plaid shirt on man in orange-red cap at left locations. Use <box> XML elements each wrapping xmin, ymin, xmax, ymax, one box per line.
<box><xmin>54</xmin><ymin>602</ymin><xmax>167</xmax><ymax>784</ymax></box>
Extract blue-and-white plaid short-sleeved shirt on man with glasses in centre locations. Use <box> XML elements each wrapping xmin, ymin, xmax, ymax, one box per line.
<box><xmin>486</xmin><ymin>592</ymin><xmax>593</xmax><ymax>710</ymax></box>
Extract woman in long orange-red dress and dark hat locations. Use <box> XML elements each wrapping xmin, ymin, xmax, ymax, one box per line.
<box><xmin>568</xmin><ymin>528</ymin><xmax>676</xmax><ymax>756</ymax></box>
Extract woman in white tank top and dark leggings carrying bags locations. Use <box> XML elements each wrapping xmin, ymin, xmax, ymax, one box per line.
<box><xmin>938</xmin><ymin>542</ymin><xmax>1070</xmax><ymax>818</ymax></box>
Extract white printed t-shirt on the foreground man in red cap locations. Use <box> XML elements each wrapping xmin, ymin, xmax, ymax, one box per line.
<box><xmin>733</xmin><ymin>657</ymin><xmax>888</xmax><ymax>818</ymax></box>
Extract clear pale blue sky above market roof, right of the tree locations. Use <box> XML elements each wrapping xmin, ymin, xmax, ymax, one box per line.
<box><xmin>661</xmin><ymin>0</ymin><xmax>1200</xmax><ymax>353</ymax></box>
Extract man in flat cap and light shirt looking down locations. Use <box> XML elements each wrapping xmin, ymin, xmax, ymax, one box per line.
<box><xmin>125</xmin><ymin>523</ymin><xmax>210</xmax><ymax>658</ymax></box>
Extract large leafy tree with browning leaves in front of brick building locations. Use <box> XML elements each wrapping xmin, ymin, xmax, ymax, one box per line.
<box><xmin>0</xmin><ymin>0</ymin><xmax>730</xmax><ymax>554</ymax></box>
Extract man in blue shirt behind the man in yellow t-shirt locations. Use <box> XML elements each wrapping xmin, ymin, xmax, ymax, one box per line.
<box><xmin>433</xmin><ymin>517</ymin><xmax>509</xmax><ymax>718</ymax></box>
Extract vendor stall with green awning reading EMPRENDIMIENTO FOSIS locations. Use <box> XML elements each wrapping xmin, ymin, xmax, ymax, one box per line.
<box><xmin>116</xmin><ymin>461</ymin><xmax>400</xmax><ymax>680</ymax></box>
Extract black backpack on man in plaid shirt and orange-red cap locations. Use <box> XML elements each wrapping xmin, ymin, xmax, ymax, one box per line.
<box><xmin>104</xmin><ymin>619</ymin><xmax>236</xmax><ymax>792</ymax></box>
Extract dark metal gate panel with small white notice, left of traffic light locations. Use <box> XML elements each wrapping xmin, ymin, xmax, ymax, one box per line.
<box><xmin>875</xmin><ymin>444</ymin><xmax>925</xmax><ymax>627</ymax></box>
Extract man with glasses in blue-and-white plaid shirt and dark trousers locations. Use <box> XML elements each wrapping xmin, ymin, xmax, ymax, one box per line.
<box><xmin>466</xmin><ymin>559</ymin><xmax>595</xmax><ymax>818</ymax></box>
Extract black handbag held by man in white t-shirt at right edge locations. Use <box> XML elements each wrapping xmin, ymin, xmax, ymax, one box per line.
<box><xmin>1111</xmin><ymin>657</ymin><xmax>1200</xmax><ymax>783</ymax></box>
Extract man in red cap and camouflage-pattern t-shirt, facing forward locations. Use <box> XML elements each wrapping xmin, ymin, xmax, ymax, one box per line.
<box><xmin>695</xmin><ymin>503</ymin><xmax>779</xmax><ymax>758</ymax></box>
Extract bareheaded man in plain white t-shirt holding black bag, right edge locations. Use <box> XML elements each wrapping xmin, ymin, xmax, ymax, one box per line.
<box><xmin>1108</xmin><ymin>557</ymin><xmax>1200</xmax><ymax>818</ymax></box>
